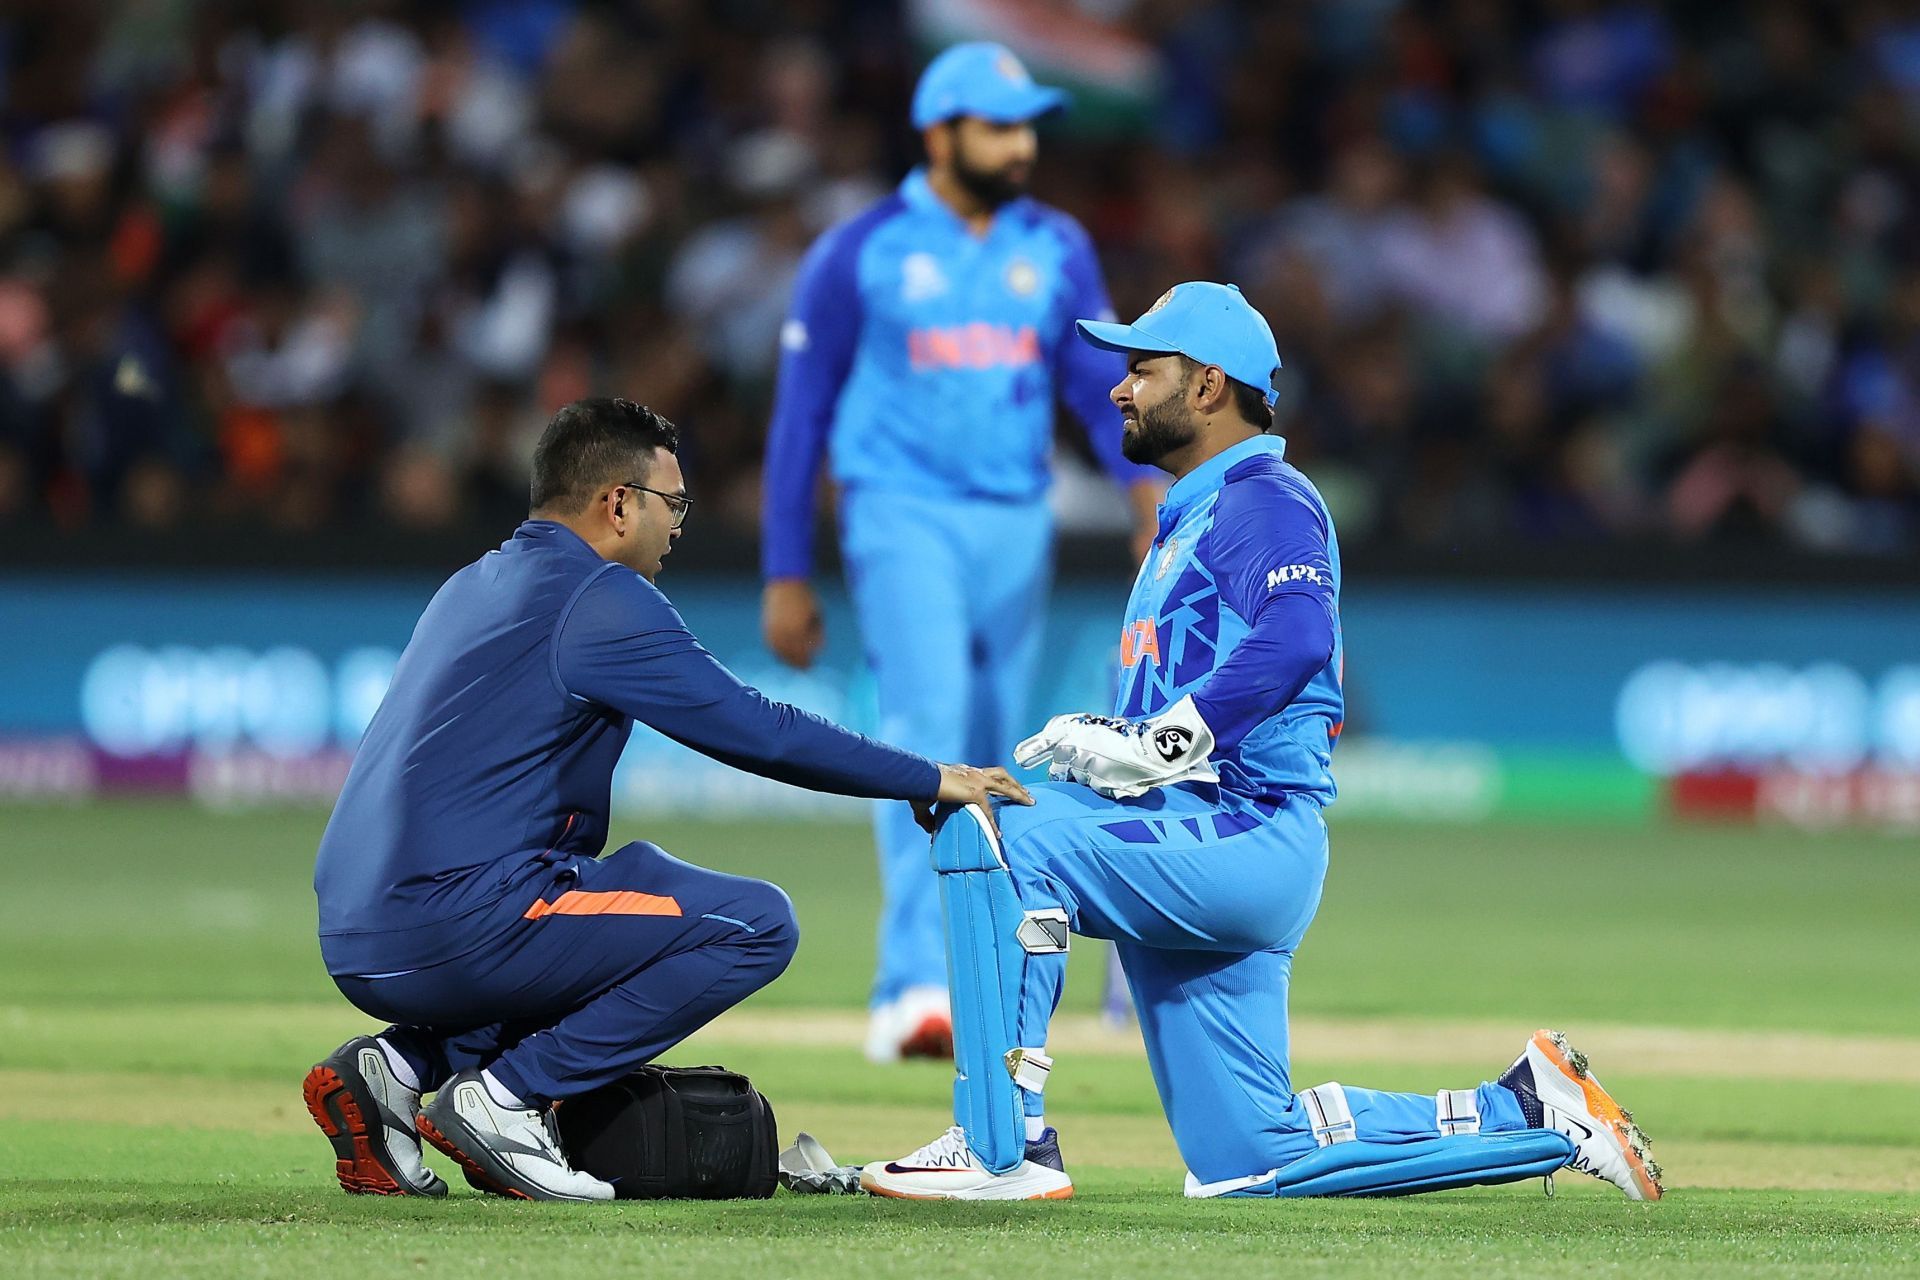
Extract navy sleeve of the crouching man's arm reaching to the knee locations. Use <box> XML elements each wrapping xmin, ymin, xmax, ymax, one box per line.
<box><xmin>553</xmin><ymin>568</ymin><xmax>941</xmax><ymax>800</ymax></box>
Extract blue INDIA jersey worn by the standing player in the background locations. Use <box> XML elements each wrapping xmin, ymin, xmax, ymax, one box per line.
<box><xmin>762</xmin><ymin>169</ymin><xmax>1150</xmax><ymax>578</ymax></box>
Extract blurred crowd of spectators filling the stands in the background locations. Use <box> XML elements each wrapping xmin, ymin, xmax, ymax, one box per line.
<box><xmin>0</xmin><ymin>0</ymin><xmax>1920</xmax><ymax>555</ymax></box>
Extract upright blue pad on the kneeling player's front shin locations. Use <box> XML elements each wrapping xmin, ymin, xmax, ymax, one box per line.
<box><xmin>933</xmin><ymin>804</ymin><xmax>1068</xmax><ymax>1173</ymax></box>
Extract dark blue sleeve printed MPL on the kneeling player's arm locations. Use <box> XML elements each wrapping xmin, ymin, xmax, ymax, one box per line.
<box><xmin>1194</xmin><ymin>478</ymin><xmax>1338</xmax><ymax>752</ymax></box>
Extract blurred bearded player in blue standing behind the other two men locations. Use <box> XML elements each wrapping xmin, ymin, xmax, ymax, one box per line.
<box><xmin>762</xmin><ymin>44</ymin><xmax>1160</xmax><ymax>1061</ymax></box>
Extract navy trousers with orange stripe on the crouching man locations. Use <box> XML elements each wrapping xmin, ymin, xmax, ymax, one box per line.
<box><xmin>334</xmin><ymin>842</ymin><xmax>799</xmax><ymax>1100</ymax></box>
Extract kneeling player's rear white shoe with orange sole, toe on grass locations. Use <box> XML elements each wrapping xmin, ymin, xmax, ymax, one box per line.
<box><xmin>1500</xmin><ymin>1031</ymin><xmax>1665</xmax><ymax>1199</ymax></box>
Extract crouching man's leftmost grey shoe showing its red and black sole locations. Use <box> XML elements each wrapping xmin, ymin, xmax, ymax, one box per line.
<box><xmin>301</xmin><ymin>1036</ymin><xmax>447</xmax><ymax>1196</ymax></box>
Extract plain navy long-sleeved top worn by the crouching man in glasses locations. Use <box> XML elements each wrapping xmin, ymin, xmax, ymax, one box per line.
<box><xmin>313</xmin><ymin>520</ymin><xmax>939</xmax><ymax>975</ymax></box>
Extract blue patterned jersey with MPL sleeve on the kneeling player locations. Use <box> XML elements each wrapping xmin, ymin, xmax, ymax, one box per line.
<box><xmin>1116</xmin><ymin>436</ymin><xmax>1346</xmax><ymax>804</ymax></box>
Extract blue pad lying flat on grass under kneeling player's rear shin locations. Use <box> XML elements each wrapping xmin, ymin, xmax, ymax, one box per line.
<box><xmin>1187</xmin><ymin>1128</ymin><xmax>1572</xmax><ymax>1197</ymax></box>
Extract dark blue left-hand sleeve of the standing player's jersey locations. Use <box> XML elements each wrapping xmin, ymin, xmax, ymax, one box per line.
<box><xmin>760</xmin><ymin>211</ymin><xmax>877</xmax><ymax>578</ymax></box>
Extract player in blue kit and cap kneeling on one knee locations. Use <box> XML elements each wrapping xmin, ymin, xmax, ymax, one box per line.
<box><xmin>862</xmin><ymin>282</ymin><xmax>1661</xmax><ymax>1199</ymax></box>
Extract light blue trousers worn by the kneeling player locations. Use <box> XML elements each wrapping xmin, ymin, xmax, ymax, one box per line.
<box><xmin>995</xmin><ymin>783</ymin><xmax>1526</xmax><ymax>1184</ymax></box>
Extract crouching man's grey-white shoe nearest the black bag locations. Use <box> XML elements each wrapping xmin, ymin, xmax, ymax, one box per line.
<box><xmin>419</xmin><ymin>1071</ymin><xmax>612</xmax><ymax>1199</ymax></box>
